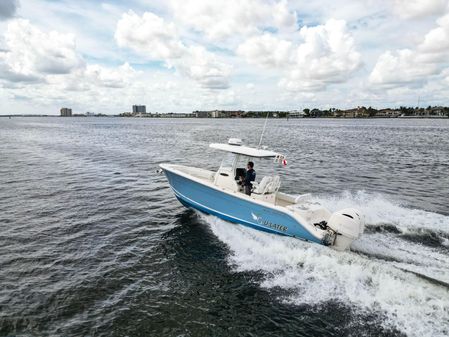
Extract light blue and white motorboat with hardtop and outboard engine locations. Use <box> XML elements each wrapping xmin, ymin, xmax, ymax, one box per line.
<box><xmin>160</xmin><ymin>138</ymin><xmax>364</xmax><ymax>251</ymax></box>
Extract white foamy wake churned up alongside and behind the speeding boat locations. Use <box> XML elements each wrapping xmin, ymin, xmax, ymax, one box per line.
<box><xmin>196</xmin><ymin>192</ymin><xmax>449</xmax><ymax>337</ymax></box>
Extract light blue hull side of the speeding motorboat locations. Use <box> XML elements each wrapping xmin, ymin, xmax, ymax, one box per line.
<box><xmin>164</xmin><ymin>169</ymin><xmax>324</xmax><ymax>244</ymax></box>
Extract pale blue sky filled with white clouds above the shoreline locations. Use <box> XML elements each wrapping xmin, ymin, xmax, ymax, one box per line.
<box><xmin>0</xmin><ymin>0</ymin><xmax>449</xmax><ymax>114</ymax></box>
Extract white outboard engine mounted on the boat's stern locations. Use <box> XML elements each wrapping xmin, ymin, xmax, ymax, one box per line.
<box><xmin>327</xmin><ymin>208</ymin><xmax>365</xmax><ymax>251</ymax></box>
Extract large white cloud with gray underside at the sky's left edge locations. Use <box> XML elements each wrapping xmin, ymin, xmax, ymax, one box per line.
<box><xmin>0</xmin><ymin>19</ymin><xmax>151</xmax><ymax>111</ymax></box>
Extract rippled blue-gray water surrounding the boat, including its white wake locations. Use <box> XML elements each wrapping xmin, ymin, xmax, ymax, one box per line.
<box><xmin>0</xmin><ymin>118</ymin><xmax>449</xmax><ymax>337</ymax></box>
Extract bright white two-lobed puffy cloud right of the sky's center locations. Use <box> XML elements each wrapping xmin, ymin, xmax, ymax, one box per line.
<box><xmin>237</xmin><ymin>19</ymin><xmax>361</xmax><ymax>91</ymax></box>
